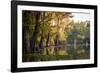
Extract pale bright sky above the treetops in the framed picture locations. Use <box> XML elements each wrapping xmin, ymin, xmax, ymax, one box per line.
<box><xmin>72</xmin><ymin>13</ymin><xmax>90</xmax><ymax>22</ymax></box>
